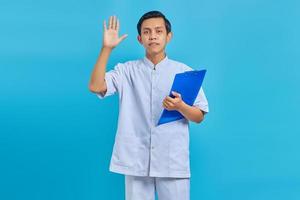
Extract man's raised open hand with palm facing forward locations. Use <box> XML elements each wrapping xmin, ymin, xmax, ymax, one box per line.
<box><xmin>103</xmin><ymin>16</ymin><xmax>128</xmax><ymax>49</ymax></box>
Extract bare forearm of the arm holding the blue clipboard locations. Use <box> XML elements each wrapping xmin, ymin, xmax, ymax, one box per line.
<box><xmin>178</xmin><ymin>102</ymin><xmax>204</xmax><ymax>123</ymax></box>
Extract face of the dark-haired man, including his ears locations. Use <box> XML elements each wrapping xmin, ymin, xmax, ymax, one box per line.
<box><xmin>138</xmin><ymin>18</ymin><xmax>172</xmax><ymax>55</ymax></box>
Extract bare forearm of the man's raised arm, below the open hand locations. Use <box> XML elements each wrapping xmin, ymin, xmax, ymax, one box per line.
<box><xmin>89</xmin><ymin>47</ymin><xmax>112</xmax><ymax>92</ymax></box>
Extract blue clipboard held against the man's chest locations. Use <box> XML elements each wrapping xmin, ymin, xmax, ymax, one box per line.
<box><xmin>157</xmin><ymin>70</ymin><xmax>206</xmax><ymax>125</ymax></box>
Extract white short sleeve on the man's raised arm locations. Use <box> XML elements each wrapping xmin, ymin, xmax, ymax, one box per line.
<box><xmin>96</xmin><ymin>63</ymin><xmax>124</xmax><ymax>99</ymax></box>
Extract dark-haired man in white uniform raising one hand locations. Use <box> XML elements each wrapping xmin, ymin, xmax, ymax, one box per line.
<box><xmin>89</xmin><ymin>11</ymin><xmax>208</xmax><ymax>200</ymax></box>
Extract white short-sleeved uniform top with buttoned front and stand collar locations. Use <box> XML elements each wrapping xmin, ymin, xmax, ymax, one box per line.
<box><xmin>97</xmin><ymin>56</ymin><xmax>208</xmax><ymax>178</ymax></box>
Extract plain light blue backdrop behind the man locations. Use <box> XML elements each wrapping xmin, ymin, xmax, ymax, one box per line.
<box><xmin>0</xmin><ymin>0</ymin><xmax>300</xmax><ymax>200</ymax></box>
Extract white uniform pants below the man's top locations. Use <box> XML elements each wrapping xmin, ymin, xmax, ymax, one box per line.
<box><xmin>125</xmin><ymin>175</ymin><xmax>190</xmax><ymax>200</ymax></box>
